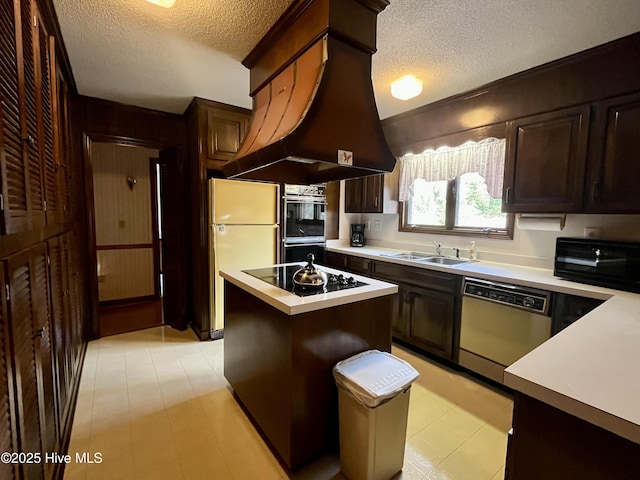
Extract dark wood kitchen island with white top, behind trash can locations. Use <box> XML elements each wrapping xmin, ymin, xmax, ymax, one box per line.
<box><xmin>220</xmin><ymin>267</ymin><xmax>397</xmax><ymax>469</ymax></box>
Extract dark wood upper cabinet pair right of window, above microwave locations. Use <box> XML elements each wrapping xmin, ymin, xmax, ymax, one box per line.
<box><xmin>503</xmin><ymin>93</ymin><xmax>640</xmax><ymax>213</ymax></box>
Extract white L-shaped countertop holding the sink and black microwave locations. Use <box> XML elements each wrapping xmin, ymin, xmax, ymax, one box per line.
<box><xmin>328</xmin><ymin>246</ymin><xmax>640</xmax><ymax>443</ymax></box>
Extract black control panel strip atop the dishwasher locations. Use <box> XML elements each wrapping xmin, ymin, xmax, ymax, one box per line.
<box><xmin>462</xmin><ymin>278</ymin><xmax>551</xmax><ymax>315</ymax></box>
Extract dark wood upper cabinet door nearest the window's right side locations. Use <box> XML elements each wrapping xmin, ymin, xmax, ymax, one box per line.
<box><xmin>503</xmin><ymin>105</ymin><xmax>590</xmax><ymax>213</ymax></box>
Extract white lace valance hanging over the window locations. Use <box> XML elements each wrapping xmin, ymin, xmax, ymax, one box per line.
<box><xmin>398</xmin><ymin>138</ymin><xmax>506</xmax><ymax>202</ymax></box>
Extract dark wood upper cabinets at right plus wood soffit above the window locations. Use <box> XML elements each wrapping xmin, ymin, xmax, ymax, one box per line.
<box><xmin>382</xmin><ymin>33</ymin><xmax>640</xmax><ymax>213</ymax></box>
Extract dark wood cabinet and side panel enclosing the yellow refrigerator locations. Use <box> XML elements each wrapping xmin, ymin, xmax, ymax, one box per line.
<box><xmin>185</xmin><ymin>98</ymin><xmax>251</xmax><ymax>340</ymax></box>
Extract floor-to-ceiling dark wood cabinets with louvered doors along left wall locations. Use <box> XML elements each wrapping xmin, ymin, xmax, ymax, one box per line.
<box><xmin>0</xmin><ymin>0</ymin><xmax>87</xmax><ymax>480</ymax></box>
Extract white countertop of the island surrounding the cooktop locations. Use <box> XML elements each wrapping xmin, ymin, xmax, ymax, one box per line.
<box><xmin>220</xmin><ymin>262</ymin><xmax>398</xmax><ymax>315</ymax></box>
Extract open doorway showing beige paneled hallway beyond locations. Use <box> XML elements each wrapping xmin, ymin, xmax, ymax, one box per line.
<box><xmin>87</xmin><ymin>140</ymin><xmax>186</xmax><ymax>337</ymax></box>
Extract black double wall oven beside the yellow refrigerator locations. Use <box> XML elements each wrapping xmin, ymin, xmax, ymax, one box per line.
<box><xmin>281</xmin><ymin>184</ymin><xmax>327</xmax><ymax>263</ymax></box>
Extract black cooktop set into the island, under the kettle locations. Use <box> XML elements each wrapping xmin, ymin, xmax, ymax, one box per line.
<box><xmin>243</xmin><ymin>263</ymin><xmax>368</xmax><ymax>297</ymax></box>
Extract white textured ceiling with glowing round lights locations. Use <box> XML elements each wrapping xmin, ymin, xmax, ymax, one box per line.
<box><xmin>53</xmin><ymin>0</ymin><xmax>640</xmax><ymax>118</ymax></box>
